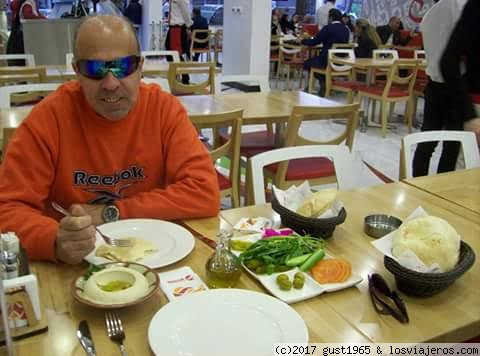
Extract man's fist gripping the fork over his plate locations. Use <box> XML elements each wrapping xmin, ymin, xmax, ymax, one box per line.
<box><xmin>55</xmin><ymin>204</ymin><xmax>95</xmax><ymax>264</ymax></box>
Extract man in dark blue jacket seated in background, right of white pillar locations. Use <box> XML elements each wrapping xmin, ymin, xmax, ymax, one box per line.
<box><xmin>301</xmin><ymin>9</ymin><xmax>350</xmax><ymax>96</ymax></box>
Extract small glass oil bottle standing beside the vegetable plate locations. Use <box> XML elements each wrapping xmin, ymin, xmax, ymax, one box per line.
<box><xmin>205</xmin><ymin>231</ymin><xmax>242</xmax><ymax>288</ymax></box>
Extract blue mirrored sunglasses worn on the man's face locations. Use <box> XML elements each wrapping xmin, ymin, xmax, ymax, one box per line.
<box><xmin>75</xmin><ymin>56</ymin><xmax>141</xmax><ymax>80</ymax></box>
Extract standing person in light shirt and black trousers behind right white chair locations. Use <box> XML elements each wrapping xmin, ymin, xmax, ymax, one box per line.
<box><xmin>412</xmin><ymin>0</ymin><xmax>466</xmax><ymax>177</ymax></box>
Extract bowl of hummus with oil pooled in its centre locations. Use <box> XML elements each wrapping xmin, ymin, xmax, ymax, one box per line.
<box><xmin>72</xmin><ymin>262</ymin><xmax>160</xmax><ymax>309</ymax></box>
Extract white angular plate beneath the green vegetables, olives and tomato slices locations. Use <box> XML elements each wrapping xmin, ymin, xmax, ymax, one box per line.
<box><xmin>244</xmin><ymin>262</ymin><xmax>362</xmax><ymax>304</ymax></box>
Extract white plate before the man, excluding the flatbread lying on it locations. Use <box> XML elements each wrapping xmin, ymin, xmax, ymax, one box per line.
<box><xmin>85</xmin><ymin>219</ymin><xmax>195</xmax><ymax>268</ymax></box>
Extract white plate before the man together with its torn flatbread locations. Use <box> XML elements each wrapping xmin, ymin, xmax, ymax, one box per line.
<box><xmin>85</xmin><ymin>219</ymin><xmax>195</xmax><ymax>268</ymax></box>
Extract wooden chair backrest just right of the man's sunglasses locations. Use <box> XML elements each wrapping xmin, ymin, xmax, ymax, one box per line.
<box><xmin>168</xmin><ymin>62</ymin><xmax>215</xmax><ymax>95</ymax></box>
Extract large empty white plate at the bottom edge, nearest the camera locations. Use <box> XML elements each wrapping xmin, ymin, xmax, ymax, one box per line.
<box><xmin>148</xmin><ymin>289</ymin><xmax>308</xmax><ymax>356</ymax></box>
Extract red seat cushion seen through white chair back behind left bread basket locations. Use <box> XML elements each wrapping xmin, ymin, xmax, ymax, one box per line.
<box><xmin>266</xmin><ymin>157</ymin><xmax>335</xmax><ymax>180</ymax></box>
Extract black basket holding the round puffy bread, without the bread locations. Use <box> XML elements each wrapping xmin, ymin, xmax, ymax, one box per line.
<box><xmin>383</xmin><ymin>241</ymin><xmax>475</xmax><ymax>297</ymax></box>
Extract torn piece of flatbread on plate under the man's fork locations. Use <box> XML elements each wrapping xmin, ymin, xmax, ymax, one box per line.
<box><xmin>95</xmin><ymin>237</ymin><xmax>158</xmax><ymax>262</ymax></box>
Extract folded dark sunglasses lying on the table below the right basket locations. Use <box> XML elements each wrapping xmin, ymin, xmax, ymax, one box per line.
<box><xmin>368</xmin><ymin>273</ymin><xmax>409</xmax><ymax>323</ymax></box>
